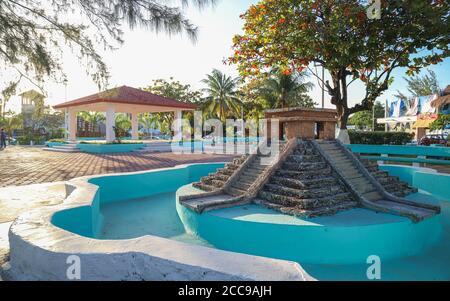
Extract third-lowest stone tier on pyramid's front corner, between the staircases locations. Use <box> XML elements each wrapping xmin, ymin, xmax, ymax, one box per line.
<box><xmin>264</xmin><ymin>184</ymin><xmax>344</xmax><ymax>199</ymax></box>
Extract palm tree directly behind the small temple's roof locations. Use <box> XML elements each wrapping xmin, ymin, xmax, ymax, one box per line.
<box><xmin>259</xmin><ymin>72</ymin><xmax>314</xmax><ymax>109</ymax></box>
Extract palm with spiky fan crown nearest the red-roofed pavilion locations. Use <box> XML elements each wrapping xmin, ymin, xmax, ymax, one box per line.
<box><xmin>202</xmin><ymin>69</ymin><xmax>242</xmax><ymax>123</ymax></box>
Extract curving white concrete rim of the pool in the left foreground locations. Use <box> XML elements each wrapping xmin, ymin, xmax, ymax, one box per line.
<box><xmin>3</xmin><ymin>165</ymin><xmax>314</xmax><ymax>281</ymax></box>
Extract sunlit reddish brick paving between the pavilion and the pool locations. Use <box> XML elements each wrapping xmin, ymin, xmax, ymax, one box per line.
<box><xmin>0</xmin><ymin>146</ymin><xmax>233</xmax><ymax>187</ymax></box>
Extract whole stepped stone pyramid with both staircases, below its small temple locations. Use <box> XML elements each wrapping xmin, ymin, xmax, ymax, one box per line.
<box><xmin>180</xmin><ymin>140</ymin><xmax>440</xmax><ymax>222</ymax></box>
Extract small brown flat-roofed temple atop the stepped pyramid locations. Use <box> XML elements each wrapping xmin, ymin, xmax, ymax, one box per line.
<box><xmin>265</xmin><ymin>107</ymin><xmax>337</xmax><ymax>139</ymax></box>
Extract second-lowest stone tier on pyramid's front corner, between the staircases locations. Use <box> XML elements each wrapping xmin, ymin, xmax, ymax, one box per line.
<box><xmin>259</xmin><ymin>190</ymin><xmax>353</xmax><ymax>209</ymax></box>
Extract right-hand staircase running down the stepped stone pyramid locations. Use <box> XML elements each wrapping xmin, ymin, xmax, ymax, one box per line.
<box><xmin>313</xmin><ymin>140</ymin><xmax>440</xmax><ymax>222</ymax></box>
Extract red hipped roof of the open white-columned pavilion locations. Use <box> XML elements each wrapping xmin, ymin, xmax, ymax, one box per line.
<box><xmin>53</xmin><ymin>86</ymin><xmax>197</xmax><ymax>110</ymax></box>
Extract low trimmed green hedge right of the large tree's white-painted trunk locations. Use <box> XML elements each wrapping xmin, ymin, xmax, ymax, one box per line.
<box><xmin>348</xmin><ymin>130</ymin><xmax>414</xmax><ymax>145</ymax></box>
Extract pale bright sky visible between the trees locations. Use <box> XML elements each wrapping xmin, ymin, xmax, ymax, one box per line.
<box><xmin>3</xmin><ymin>0</ymin><xmax>450</xmax><ymax>111</ymax></box>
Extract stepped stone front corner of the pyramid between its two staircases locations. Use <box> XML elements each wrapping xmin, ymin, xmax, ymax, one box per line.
<box><xmin>255</xmin><ymin>141</ymin><xmax>358</xmax><ymax>217</ymax></box>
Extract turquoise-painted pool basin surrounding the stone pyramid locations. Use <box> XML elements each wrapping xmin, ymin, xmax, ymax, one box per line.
<box><xmin>52</xmin><ymin>164</ymin><xmax>450</xmax><ymax>280</ymax></box>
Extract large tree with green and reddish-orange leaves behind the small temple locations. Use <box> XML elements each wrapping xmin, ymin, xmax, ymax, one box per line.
<box><xmin>229</xmin><ymin>0</ymin><xmax>450</xmax><ymax>129</ymax></box>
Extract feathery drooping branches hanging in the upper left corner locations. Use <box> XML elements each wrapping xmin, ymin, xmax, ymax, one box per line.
<box><xmin>0</xmin><ymin>0</ymin><xmax>215</xmax><ymax>87</ymax></box>
